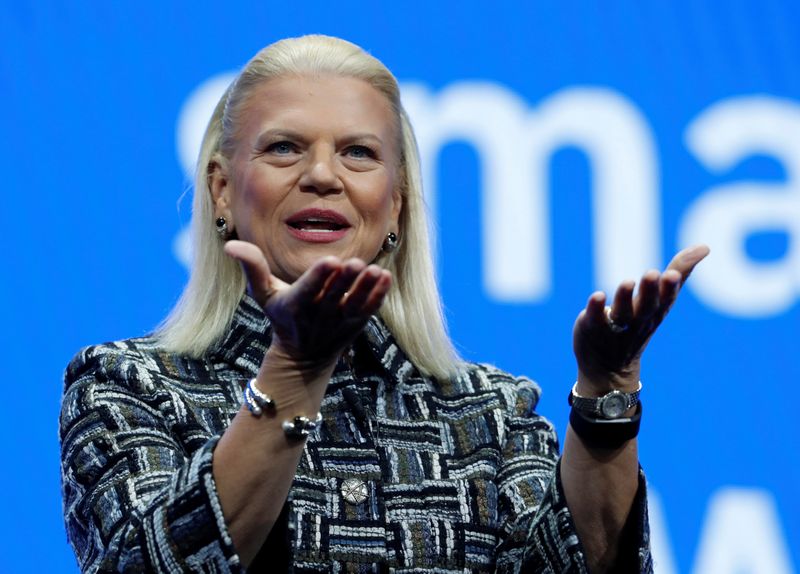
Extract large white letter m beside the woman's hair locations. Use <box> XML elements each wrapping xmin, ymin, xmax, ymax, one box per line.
<box><xmin>403</xmin><ymin>82</ymin><xmax>661</xmax><ymax>302</ymax></box>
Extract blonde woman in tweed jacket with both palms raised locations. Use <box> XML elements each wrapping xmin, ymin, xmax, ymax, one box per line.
<box><xmin>61</xmin><ymin>36</ymin><xmax>707</xmax><ymax>572</ymax></box>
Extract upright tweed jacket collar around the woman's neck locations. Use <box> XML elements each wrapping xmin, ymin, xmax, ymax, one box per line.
<box><xmin>209</xmin><ymin>293</ymin><xmax>419</xmax><ymax>384</ymax></box>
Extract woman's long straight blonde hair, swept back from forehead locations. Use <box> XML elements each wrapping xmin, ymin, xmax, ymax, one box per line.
<box><xmin>156</xmin><ymin>35</ymin><xmax>461</xmax><ymax>378</ymax></box>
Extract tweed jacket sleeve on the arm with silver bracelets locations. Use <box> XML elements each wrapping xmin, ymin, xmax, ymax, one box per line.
<box><xmin>60</xmin><ymin>345</ymin><xmax>243</xmax><ymax>573</ymax></box>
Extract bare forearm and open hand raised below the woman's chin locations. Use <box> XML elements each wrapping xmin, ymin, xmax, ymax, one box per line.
<box><xmin>213</xmin><ymin>240</ymin><xmax>392</xmax><ymax>565</ymax></box>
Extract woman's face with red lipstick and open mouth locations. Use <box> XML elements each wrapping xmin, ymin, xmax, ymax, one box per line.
<box><xmin>211</xmin><ymin>76</ymin><xmax>402</xmax><ymax>282</ymax></box>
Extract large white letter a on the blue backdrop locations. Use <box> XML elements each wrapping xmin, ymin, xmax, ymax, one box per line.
<box><xmin>679</xmin><ymin>96</ymin><xmax>800</xmax><ymax>317</ymax></box>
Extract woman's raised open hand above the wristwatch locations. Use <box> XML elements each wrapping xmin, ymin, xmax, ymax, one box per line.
<box><xmin>573</xmin><ymin>245</ymin><xmax>709</xmax><ymax>395</ymax></box>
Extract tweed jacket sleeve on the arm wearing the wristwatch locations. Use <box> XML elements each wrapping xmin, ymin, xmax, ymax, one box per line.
<box><xmin>490</xmin><ymin>372</ymin><xmax>652</xmax><ymax>574</ymax></box>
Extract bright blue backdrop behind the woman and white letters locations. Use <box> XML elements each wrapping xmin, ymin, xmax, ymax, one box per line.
<box><xmin>0</xmin><ymin>0</ymin><xmax>800</xmax><ymax>572</ymax></box>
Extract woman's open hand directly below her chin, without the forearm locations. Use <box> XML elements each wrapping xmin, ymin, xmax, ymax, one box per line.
<box><xmin>225</xmin><ymin>240</ymin><xmax>392</xmax><ymax>364</ymax></box>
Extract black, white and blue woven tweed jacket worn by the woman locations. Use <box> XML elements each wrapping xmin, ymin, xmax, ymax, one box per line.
<box><xmin>60</xmin><ymin>296</ymin><xmax>652</xmax><ymax>574</ymax></box>
